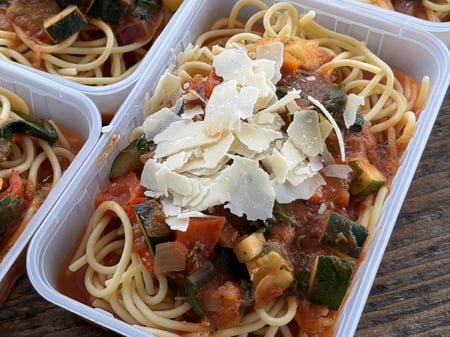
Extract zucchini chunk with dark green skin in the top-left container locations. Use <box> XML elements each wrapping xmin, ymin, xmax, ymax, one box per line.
<box><xmin>44</xmin><ymin>5</ymin><xmax>87</xmax><ymax>43</ymax></box>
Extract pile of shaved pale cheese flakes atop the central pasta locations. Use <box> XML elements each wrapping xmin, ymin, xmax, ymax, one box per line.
<box><xmin>141</xmin><ymin>42</ymin><xmax>351</xmax><ymax>230</ymax></box>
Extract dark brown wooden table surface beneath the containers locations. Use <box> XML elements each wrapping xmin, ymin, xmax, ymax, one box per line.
<box><xmin>0</xmin><ymin>90</ymin><xmax>450</xmax><ymax>337</ymax></box>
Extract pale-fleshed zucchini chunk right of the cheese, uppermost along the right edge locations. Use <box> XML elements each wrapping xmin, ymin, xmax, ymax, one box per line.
<box><xmin>349</xmin><ymin>158</ymin><xmax>386</xmax><ymax>195</ymax></box>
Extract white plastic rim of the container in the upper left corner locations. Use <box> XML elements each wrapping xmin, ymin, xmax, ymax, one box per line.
<box><xmin>0</xmin><ymin>0</ymin><xmax>189</xmax><ymax>120</ymax></box>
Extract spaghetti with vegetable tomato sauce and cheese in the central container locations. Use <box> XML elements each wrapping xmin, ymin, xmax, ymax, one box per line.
<box><xmin>61</xmin><ymin>0</ymin><xmax>429</xmax><ymax>336</ymax></box>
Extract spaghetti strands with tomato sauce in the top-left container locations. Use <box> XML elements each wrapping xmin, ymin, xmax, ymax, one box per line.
<box><xmin>0</xmin><ymin>0</ymin><xmax>181</xmax><ymax>86</ymax></box>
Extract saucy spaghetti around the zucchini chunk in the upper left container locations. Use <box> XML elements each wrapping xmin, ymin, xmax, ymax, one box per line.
<box><xmin>0</xmin><ymin>0</ymin><xmax>180</xmax><ymax>86</ymax></box>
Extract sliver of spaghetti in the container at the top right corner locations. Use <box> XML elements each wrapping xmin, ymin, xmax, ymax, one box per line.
<box><xmin>360</xmin><ymin>0</ymin><xmax>450</xmax><ymax>22</ymax></box>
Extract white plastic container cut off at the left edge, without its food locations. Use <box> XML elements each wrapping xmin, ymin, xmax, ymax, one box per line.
<box><xmin>0</xmin><ymin>63</ymin><xmax>101</xmax><ymax>290</ymax></box>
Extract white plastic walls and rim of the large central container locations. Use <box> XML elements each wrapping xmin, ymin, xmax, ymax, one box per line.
<box><xmin>27</xmin><ymin>0</ymin><xmax>450</xmax><ymax>337</ymax></box>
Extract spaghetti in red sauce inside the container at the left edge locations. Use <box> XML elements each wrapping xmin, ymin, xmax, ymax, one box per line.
<box><xmin>0</xmin><ymin>88</ymin><xmax>81</xmax><ymax>259</ymax></box>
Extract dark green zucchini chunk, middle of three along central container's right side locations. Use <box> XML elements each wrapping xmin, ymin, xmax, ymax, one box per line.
<box><xmin>320</xmin><ymin>211</ymin><xmax>368</xmax><ymax>259</ymax></box>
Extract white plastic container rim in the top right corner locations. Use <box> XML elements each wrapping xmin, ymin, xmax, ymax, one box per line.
<box><xmin>339</xmin><ymin>0</ymin><xmax>450</xmax><ymax>48</ymax></box>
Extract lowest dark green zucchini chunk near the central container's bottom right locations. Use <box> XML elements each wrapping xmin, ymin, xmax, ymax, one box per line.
<box><xmin>307</xmin><ymin>256</ymin><xmax>355</xmax><ymax>310</ymax></box>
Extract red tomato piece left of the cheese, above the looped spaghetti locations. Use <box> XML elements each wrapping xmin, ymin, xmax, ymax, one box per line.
<box><xmin>95</xmin><ymin>172</ymin><xmax>146</xmax><ymax>218</ymax></box>
